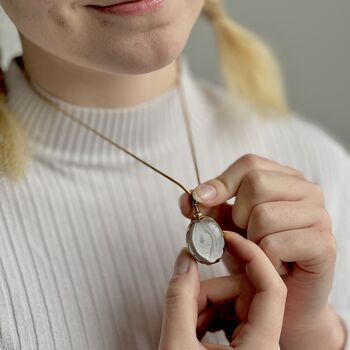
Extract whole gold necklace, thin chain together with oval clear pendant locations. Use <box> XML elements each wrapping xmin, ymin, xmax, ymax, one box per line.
<box><xmin>15</xmin><ymin>56</ymin><xmax>225</xmax><ymax>265</ymax></box>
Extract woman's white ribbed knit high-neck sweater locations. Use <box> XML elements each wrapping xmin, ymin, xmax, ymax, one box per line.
<box><xmin>0</xmin><ymin>58</ymin><xmax>350</xmax><ymax>350</ymax></box>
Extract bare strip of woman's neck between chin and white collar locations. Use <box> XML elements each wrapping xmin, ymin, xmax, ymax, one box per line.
<box><xmin>22</xmin><ymin>38</ymin><xmax>177</xmax><ymax>108</ymax></box>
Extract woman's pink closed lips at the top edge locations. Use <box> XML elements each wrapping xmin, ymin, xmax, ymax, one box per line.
<box><xmin>87</xmin><ymin>0</ymin><xmax>167</xmax><ymax>16</ymax></box>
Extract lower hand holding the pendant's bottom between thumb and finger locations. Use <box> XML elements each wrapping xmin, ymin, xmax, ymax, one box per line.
<box><xmin>159</xmin><ymin>232</ymin><xmax>286</xmax><ymax>350</ymax></box>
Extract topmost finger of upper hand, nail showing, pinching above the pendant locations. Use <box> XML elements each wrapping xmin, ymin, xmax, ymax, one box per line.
<box><xmin>193</xmin><ymin>154</ymin><xmax>304</xmax><ymax>207</ymax></box>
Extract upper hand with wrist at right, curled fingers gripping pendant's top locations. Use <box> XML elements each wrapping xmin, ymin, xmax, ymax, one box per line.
<box><xmin>180</xmin><ymin>155</ymin><xmax>344</xmax><ymax>350</ymax></box>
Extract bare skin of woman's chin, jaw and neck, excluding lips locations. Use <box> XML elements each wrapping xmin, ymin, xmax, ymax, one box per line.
<box><xmin>0</xmin><ymin>0</ymin><xmax>204</xmax><ymax>108</ymax></box>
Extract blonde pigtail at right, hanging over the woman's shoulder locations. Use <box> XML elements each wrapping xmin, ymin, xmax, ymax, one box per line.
<box><xmin>203</xmin><ymin>0</ymin><xmax>288</xmax><ymax>116</ymax></box>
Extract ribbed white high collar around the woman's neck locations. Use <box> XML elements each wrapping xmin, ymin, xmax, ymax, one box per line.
<box><xmin>5</xmin><ymin>57</ymin><xmax>215</xmax><ymax>165</ymax></box>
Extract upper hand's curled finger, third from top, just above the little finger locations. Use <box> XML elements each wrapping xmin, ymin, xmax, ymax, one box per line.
<box><xmin>247</xmin><ymin>201</ymin><xmax>332</xmax><ymax>243</ymax></box>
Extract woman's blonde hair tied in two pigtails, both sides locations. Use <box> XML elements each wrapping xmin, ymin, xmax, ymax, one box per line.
<box><xmin>0</xmin><ymin>0</ymin><xmax>288</xmax><ymax>181</ymax></box>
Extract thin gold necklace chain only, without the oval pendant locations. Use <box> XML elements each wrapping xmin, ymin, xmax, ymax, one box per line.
<box><xmin>16</xmin><ymin>57</ymin><xmax>200</xmax><ymax>195</ymax></box>
